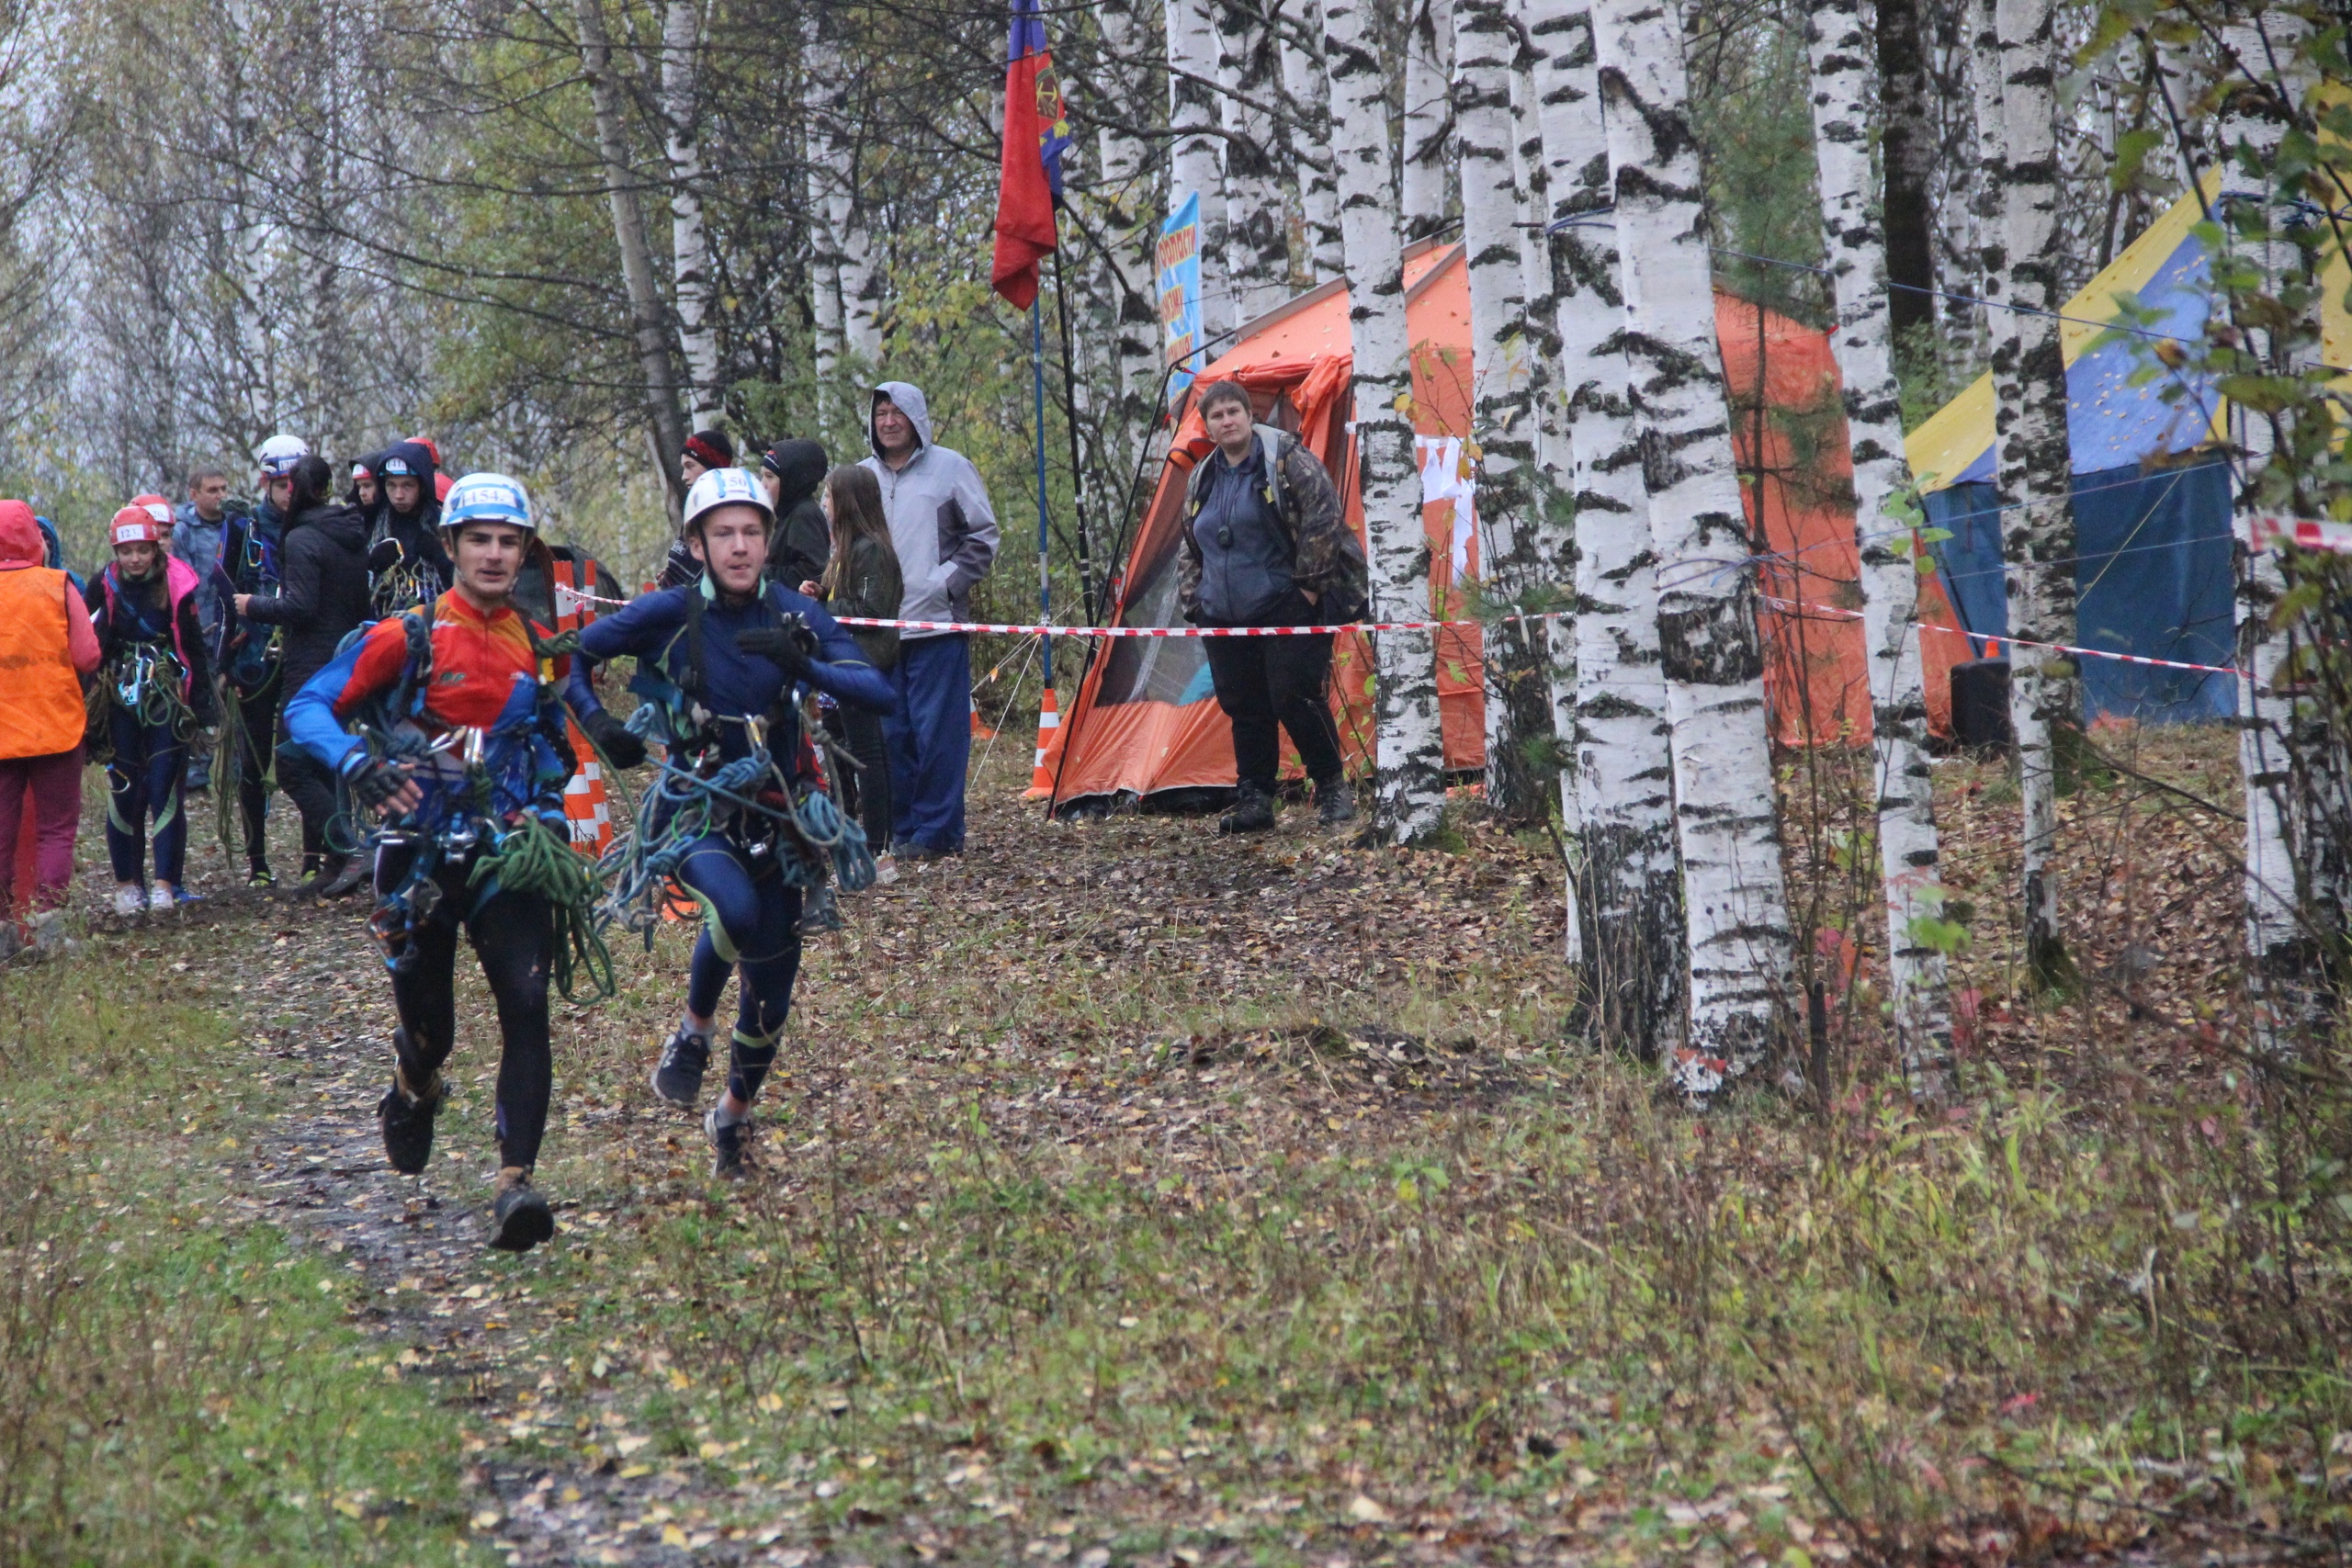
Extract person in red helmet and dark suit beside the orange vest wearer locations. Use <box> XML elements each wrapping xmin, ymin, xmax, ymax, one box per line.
<box><xmin>83</xmin><ymin>503</ymin><xmax>211</xmax><ymax>917</ymax></box>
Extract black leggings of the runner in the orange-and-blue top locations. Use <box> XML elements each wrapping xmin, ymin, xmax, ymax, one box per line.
<box><xmin>377</xmin><ymin>844</ymin><xmax>555</xmax><ymax>1168</ymax></box>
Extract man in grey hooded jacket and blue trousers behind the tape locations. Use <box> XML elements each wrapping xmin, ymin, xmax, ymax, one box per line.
<box><xmin>865</xmin><ymin>381</ymin><xmax>997</xmax><ymax>861</ymax></box>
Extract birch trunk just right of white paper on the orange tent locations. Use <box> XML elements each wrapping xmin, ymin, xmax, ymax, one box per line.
<box><xmin>1453</xmin><ymin>0</ymin><xmax>1553</xmax><ymax>820</ymax></box>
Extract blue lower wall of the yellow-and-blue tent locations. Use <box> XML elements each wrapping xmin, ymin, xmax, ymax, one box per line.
<box><xmin>1924</xmin><ymin>446</ymin><xmax>2237</xmax><ymax>724</ymax></box>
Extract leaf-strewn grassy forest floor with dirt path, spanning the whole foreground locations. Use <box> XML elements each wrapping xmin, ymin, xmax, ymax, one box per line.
<box><xmin>0</xmin><ymin>728</ymin><xmax>2352</xmax><ymax>1568</ymax></box>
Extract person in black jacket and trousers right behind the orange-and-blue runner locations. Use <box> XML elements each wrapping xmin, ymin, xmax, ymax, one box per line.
<box><xmin>238</xmin><ymin>451</ymin><xmax>369</xmax><ymax>898</ymax></box>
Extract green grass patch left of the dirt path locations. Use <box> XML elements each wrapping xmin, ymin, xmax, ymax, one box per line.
<box><xmin>0</xmin><ymin>959</ymin><xmax>477</xmax><ymax>1563</ymax></box>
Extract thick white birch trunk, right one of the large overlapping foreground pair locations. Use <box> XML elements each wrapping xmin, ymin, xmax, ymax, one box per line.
<box><xmin>1592</xmin><ymin>0</ymin><xmax>1792</xmax><ymax>1098</ymax></box>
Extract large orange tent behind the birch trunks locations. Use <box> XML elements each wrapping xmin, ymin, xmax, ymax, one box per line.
<box><xmin>1054</xmin><ymin>275</ymin><xmax>1870</xmax><ymax>811</ymax></box>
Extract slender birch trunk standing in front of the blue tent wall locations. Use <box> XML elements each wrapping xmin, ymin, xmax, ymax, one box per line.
<box><xmin>1992</xmin><ymin>0</ymin><xmax>2082</xmax><ymax>985</ymax></box>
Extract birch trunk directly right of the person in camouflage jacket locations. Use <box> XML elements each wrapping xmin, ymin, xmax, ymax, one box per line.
<box><xmin>1324</xmin><ymin>0</ymin><xmax>1446</xmax><ymax>844</ymax></box>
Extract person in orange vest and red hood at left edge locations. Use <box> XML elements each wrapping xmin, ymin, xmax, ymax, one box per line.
<box><xmin>0</xmin><ymin>501</ymin><xmax>99</xmax><ymax>950</ymax></box>
